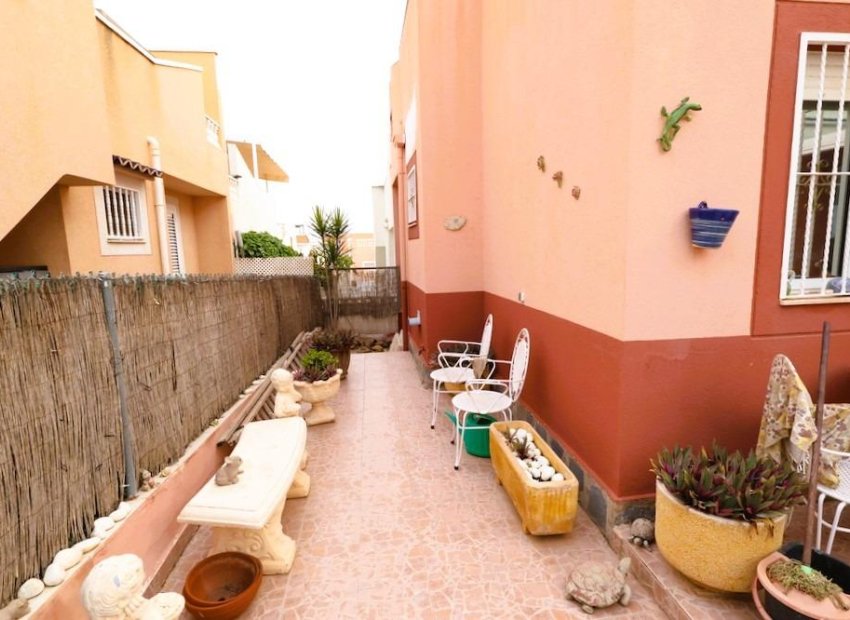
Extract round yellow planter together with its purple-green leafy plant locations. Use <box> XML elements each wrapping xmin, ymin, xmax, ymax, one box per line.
<box><xmin>652</xmin><ymin>444</ymin><xmax>806</xmax><ymax>592</ymax></box>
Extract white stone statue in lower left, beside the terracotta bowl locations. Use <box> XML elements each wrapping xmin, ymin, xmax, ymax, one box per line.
<box><xmin>82</xmin><ymin>553</ymin><xmax>186</xmax><ymax>620</ymax></box>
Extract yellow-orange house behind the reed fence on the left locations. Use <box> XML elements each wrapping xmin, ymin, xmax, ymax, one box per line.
<box><xmin>0</xmin><ymin>0</ymin><xmax>233</xmax><ymax>275</ymax></box>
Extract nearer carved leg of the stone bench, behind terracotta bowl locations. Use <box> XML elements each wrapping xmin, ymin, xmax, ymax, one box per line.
<box><xmin>209</xmin><ymin>497</ymin><xmax>295</xmax><ymax>575</ymax></box>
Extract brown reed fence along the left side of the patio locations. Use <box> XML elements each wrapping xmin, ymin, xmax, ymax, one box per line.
<box><xmin>0</xmin><ymin>276</ymin><xmax>322</xmax><ymax>603</ymax></box>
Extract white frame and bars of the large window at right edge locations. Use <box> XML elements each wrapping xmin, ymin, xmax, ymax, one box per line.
<box><xmin>779</xmin><ymin>32</ymin><xmax>850</xmax><ymax>305</ymax></box>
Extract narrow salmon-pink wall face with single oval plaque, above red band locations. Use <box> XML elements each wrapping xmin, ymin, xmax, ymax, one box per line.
<box><xmin>408</xmin><ymin>1</ymin><xmax>484</xmax><ymax>293</ymax></box>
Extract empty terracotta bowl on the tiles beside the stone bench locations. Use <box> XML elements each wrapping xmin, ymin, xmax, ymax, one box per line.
<box><xmin>183</xmin><ymin>551</ymin><xmax>256</xmax><ymax>620</ymax></box>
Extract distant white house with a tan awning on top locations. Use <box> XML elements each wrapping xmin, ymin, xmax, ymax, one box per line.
<box><xmin>227</xmin><ymin>140</ymin><xmax>289</xmax><ymax>242</ymax></box>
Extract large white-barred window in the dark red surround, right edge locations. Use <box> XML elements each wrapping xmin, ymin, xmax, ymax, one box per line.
<box><xmin>780</xmin><ymin>33</ymin><xmax>850</xmax><ymax>301</ymax></box>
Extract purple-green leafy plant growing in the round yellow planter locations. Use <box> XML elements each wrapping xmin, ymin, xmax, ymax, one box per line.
<box><xmin>651</xmin><ymin>444</ymin><xmax>807</xmax><ymax>522</ymax></box>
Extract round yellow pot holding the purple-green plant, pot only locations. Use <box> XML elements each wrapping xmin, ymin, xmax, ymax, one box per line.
<box><xmin>655</xmin><ymin>482</ymin><xmax>787</xmax><ymax>592</ymax></box>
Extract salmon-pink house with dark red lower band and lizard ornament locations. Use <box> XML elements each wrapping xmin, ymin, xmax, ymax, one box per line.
<box><xmin>390</xmin><ymin>0</ymin><xmax>850</xmax><ymax>512</ymax></box>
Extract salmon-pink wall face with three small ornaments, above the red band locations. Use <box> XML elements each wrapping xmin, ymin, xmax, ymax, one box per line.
<box><xmin>482</xmin><ymin>0</ymin><xmax>632</xmax><ymax>337</ymax></box>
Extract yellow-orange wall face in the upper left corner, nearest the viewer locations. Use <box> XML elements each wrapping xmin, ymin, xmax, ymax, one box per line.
<box><xmin>0</xmin><ymin>0</ymin><xmax>114</xmax><ymax>239</ymax></box>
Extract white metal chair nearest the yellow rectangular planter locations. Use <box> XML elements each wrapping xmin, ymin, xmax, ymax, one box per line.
<box><xmin>452</xmin><ymin>329</ymin><xmax>531</xmax><ymax>469</ymax></box>
